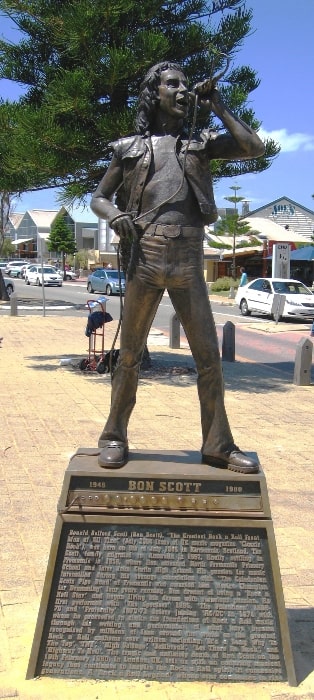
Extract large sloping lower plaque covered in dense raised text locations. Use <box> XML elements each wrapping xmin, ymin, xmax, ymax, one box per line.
<box><xmin>28</xmin><ymin>513</ymin><xmax>295</xmax><ymax>684</ymax></box>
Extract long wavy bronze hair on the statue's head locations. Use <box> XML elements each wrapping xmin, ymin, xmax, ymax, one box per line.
<box><xmin>135</xmin><ymin>61</ymin><xmax>184</xmax><ymax>136</ymax></box>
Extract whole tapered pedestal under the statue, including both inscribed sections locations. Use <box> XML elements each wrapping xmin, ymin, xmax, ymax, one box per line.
<box><xmin>27</xmin><ymin>449</ymin><xmax>296</xmax><ymax>685</ymax></box>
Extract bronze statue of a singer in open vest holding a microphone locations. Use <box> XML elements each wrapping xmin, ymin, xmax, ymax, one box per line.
<box><xmin>91</xmin><ymin>62</ymin><xmax>264</xmax><ymax>473</ymax></box>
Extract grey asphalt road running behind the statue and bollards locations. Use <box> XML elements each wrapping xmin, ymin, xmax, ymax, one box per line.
<box><xmin>2</xmin><ymin>279</ymin><xmax>311</xmax><ymax>376</ymax></box>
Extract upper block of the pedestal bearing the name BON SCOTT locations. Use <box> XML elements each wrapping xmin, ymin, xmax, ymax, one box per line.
<box><xmin>58</xmin><ymin>449</ymin><xmax>270</xmax><ymax>517</ymax></box>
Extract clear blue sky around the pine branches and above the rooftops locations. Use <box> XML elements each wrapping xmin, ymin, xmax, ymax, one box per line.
<box><xmin>0</xmin><ymin>0</ymin><xmax>314</xmax><ymax>211</ymax></box>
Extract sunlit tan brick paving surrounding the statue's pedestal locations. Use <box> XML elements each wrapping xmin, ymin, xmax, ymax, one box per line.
<box><xmin>0</xmin><ymin>314</ymin><xmax>314</xmax><ymax>700</ymax></box>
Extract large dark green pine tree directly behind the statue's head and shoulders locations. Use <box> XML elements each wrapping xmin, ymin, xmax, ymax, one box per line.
<box><xmin>0</xmin><ymin>0</ymin><xmax>278</xmax><ymax>203</ymax></box>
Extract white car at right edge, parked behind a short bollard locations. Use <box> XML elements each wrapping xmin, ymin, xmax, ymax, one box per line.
<box><xmin>235</xmin><ymin>277</ymin><xmax>314</xmax><ymax>319</ymax></box>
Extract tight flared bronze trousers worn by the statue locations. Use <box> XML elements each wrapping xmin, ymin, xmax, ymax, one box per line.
<box><xmin>100</xmin><ymin>230</ymin><xmax>234</xmax><ymax>455</ymax></box>
